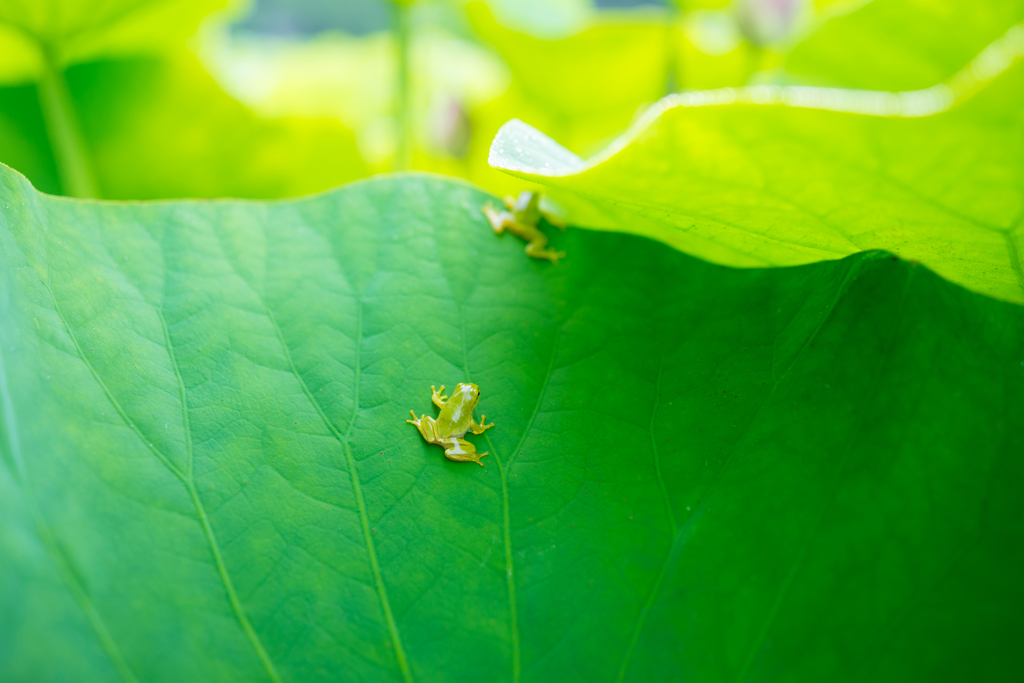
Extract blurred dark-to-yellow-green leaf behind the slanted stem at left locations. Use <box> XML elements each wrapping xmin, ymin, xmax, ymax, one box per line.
<box><xmin>0</xmin><ymin>51</ymin><xmax>369</xmax><ymax>199</ymax></box>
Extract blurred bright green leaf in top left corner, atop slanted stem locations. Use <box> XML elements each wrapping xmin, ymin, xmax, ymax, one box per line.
<box><xmin>0</xmin><ymin>0</ymin><xmax>239</xmax><ymax>82</ymax></box>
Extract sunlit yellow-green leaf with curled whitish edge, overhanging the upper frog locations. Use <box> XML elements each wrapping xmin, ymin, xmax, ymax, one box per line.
<box><xmin>490</xmin><ymin>26</ymin><xmax>1024</xmax><ymax>303</ymax></box>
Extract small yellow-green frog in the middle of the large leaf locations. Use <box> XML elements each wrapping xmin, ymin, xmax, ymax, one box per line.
<box><xmin>406</xmin><ymin>383</ymin><xmax>495</xmax><ymax>467</ymax></box>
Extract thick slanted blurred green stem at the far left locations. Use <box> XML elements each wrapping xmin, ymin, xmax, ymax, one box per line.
<box><xmin>38</xmin><ymin>48</ymin><xmax>99</xmax><ymax>198</ymax></box>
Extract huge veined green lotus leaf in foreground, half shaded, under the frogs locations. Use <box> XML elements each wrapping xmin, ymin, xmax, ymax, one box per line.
<box><xmin>0</xmin><ymin>162</ymin><xmax>1024</xmax><ymax>683</ymax></box>
